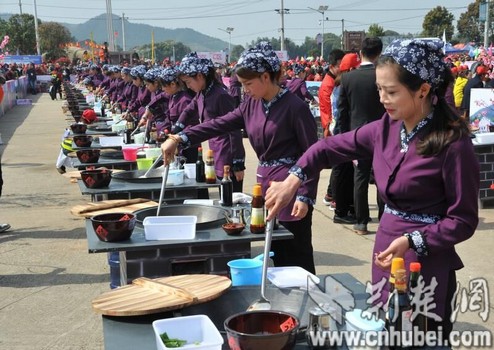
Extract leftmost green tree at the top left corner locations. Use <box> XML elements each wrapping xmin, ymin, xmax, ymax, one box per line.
<box><xmin>6</xmin><ymin>13</ymin><xmax>41</xmax><ymax>55</ymax></box>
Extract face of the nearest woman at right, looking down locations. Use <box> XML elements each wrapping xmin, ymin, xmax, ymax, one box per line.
<box><xmin>376</xmin><ymin>64</ymin><xmax>425</xmax><ymax>121</ymax></box>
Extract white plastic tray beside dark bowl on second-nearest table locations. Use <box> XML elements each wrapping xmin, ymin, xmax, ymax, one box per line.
<box><xmin>143</xmin><ymin>215</ymin><xmax>197</xmax><ymax>241</ymax></box>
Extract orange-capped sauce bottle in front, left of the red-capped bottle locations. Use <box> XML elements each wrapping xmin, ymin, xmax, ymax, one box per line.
<box><xmin>386</xmin><ymin>269</ymin><xmax>413</xmax><ymax>349</ymax></box>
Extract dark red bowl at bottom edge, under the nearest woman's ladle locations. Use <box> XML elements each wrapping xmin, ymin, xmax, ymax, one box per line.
<box><xmin>224</xmin><ymin>310</ymin><xmax>300</xmax><ymax>350</ymax></box>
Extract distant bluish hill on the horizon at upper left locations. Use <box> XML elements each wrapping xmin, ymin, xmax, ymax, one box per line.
<box><xmin>0</xmin><ymin>13</ymin><xmax>228</xmax><ymax>51</ymax></box>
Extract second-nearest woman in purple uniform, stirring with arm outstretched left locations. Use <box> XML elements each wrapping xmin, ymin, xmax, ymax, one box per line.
<box><xmin>162</xmin><ymin>42</ymin><xmax>319</xmax><ymax>273</ymax></box>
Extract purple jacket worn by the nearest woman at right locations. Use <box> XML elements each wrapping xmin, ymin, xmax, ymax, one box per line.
<box><xmin>298</xmin><ymin>114</ymin><xmax>480</xmax><ymax>317</ymax></box>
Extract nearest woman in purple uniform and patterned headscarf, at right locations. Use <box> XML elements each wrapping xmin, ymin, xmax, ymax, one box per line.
<box><xmin>266</xmin><ymin>39</ymin><xmax>479</xmax><ymax>337</ymax></box>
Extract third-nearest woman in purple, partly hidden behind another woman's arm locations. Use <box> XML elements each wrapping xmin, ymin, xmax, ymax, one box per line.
<box><xmin>175</xmin><ymin>52</ymin><xmax>245</xmax><ymax>192</ymax></box>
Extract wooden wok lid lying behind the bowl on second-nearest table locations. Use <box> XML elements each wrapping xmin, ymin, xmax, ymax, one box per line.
<box><xmin>70</xmin><ymin>198</ymin><xmax>158</xmax><ymax>218</ymax></box>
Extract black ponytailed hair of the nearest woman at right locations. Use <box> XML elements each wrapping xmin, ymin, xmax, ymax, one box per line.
<box><xmin>377</xmin><ymin>56</ymin><xmax>470</xmax><ymax>157</ymax></box>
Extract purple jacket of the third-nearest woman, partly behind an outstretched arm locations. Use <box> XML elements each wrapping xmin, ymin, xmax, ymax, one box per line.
<box><xmin>178</xmin><ymin>84</ymin><xmax>245</xmax><ymax>177</ymax></box>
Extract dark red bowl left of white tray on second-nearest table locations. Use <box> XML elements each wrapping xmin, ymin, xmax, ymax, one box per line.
<box><xmin>90</xmin><ymin>213</ymin><xmax>136</xmax><ymax>242</ymax></box>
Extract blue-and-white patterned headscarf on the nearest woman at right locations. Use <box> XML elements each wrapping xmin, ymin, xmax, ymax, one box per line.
<box><xmin>382</xmin><ymin>39</ymin><xmax>446</xmax><ymax>90</ymax></box>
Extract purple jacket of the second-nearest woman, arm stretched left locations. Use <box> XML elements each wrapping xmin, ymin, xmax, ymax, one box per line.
<box><xmin>185</xmin><ymin>92</ymin><xmax>319</xmax><ymax>221</ymax></box>
